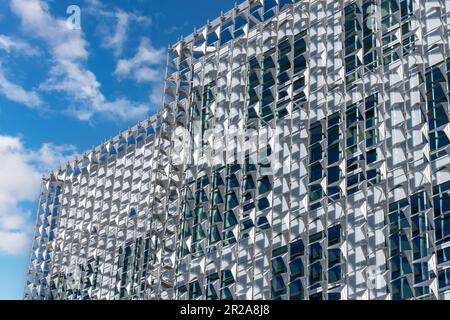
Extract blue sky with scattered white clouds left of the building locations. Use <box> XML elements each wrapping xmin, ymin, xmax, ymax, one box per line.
<box><xmin>0</xmin><ymin>0</ymin><xmax>235</xmax><ymax>299</ymax></box>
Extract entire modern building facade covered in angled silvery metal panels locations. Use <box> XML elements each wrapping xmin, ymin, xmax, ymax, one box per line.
<box><xmin>25</xmin><ymin>0</ymin><xmax>450</xmax><ymax>300</ymax></box>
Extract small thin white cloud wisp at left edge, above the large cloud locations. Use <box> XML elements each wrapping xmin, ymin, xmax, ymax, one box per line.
<box><xmin>0</xmin><ymin>64</ymin><xmax>42</xmax><ymax>108</ymax></box>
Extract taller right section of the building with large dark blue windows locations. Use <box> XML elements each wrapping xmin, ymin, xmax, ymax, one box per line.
<box><xmin>166</xmin><ymin>0</ymin><xmax>450</xmax><ymax>299</ymax></box>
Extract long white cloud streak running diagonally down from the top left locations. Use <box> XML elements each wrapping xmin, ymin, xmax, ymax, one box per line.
<box><xmin>10</xmin><ymin>0</ymin><xmax>150</xmax><ymax>121</ymax></box>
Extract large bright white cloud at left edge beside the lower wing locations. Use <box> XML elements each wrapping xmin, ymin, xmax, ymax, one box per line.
<box><xmin>0</xmin><ymin>135</ymin><xmax>75</xmax><ymax>255</ymax></box>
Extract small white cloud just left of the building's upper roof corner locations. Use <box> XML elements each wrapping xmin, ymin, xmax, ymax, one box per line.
<box><xmin>114</xmin><ymin>38</ymin><xmax>165</xmax><ymax>83</ymax></box>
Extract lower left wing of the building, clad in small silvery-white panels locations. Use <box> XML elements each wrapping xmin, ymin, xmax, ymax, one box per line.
<box><xmin>25</xmin><ymin>117</ymin><xmax>174</xmax><ymax>299</ymax></box>
